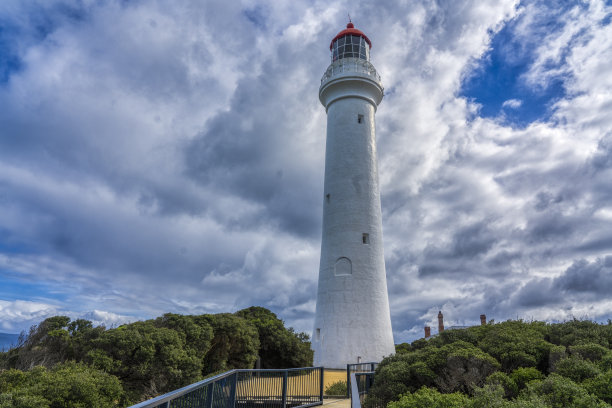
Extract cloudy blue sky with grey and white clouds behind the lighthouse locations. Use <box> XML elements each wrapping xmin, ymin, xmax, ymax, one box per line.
<box><xmin>0</xmin><ymin>0</ymin><xmax>612</xmax><ymax>343</ymax></box>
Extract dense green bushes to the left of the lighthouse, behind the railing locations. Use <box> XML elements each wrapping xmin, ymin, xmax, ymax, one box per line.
<box><xmin>0</xmin><ymin>308</ymin><xmax>312</xmax><ymax>408</ymax></box>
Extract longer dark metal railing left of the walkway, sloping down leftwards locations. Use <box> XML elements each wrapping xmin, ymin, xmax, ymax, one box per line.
<box><xmin>130</xmin><ymin>367</ymin><xmax>323</xmax><ymax>408</ymax></box>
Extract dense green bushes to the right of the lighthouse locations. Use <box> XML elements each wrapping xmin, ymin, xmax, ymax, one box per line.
<box><xmin>368</xmin><ymin>320</ymin><xmax>612</xmax><ymax>408</ymax></box>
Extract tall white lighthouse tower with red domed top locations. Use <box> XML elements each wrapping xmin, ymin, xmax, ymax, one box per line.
<box><xmin>312</xmin><ymin>23</ymin><xmax>395</xmax><ymax>368</ymax></box>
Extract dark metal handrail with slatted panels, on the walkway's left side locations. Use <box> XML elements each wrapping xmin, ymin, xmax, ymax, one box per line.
<box><xmin>130</xmin><ymin>367</ymin><xmax>323</xmax><ymax>408</ymax></box>
